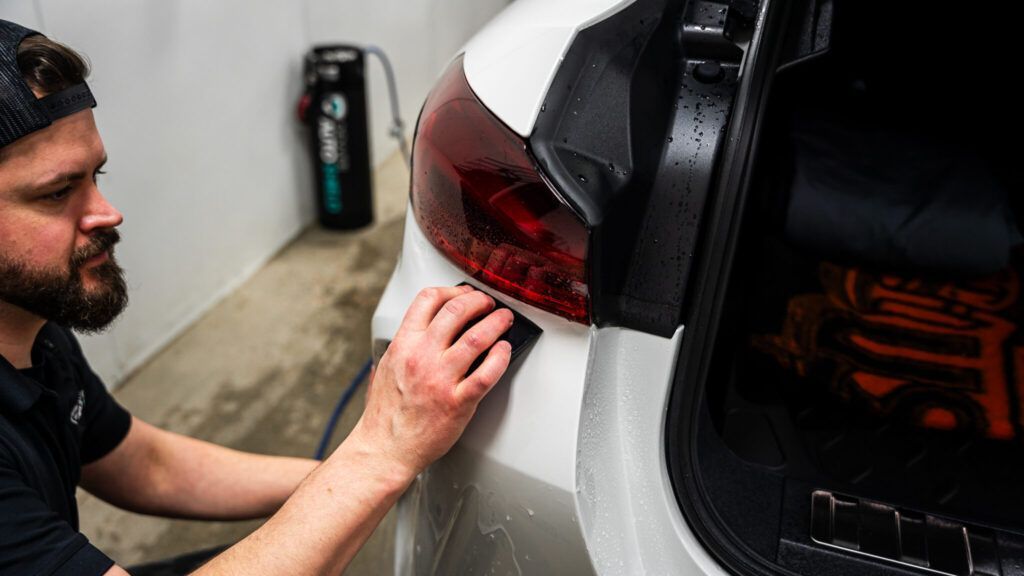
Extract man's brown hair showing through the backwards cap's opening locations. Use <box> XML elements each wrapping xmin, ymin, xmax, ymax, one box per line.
<box><xmin>17</xmin><ymin>34</ymin><xmax>89</xmax><ymax>96</ymax></box>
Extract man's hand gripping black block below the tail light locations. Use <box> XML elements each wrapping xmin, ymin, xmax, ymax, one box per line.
<box><xmin>351</xmin><ymin>286</ymin><xmax>512</xmax><ymax>476</ymax></box>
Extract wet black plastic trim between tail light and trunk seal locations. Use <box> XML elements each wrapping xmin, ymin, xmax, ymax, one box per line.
<box><xmin>529</xmin><ymin>0</ymin><xmax>746</xmax><ymax>336</ymax></box>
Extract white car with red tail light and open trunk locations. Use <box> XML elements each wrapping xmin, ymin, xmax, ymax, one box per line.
<box><xmin>373</xmin><ymin>0</ymin><xmax>1024</xmax><ymax>576</ymax></box>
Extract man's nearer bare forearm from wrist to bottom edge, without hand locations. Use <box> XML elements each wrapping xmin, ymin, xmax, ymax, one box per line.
<box><xmin>195</xmin><ymin>429</ymin><xmax>416</xmax><ymax>576</ymax></box>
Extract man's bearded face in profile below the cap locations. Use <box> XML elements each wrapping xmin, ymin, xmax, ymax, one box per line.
<box><xmin>0</xmin><ymin>110</ymin><xmax>127</xmax><ymax>332</ymax></box>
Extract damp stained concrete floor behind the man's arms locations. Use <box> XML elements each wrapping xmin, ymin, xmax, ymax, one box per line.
<box><xmin>79</xmin><ymin>148</ymin><xmax>409</xmax><ymax>575</ymax></box>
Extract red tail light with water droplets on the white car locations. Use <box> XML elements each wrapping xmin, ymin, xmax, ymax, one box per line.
<box><xmin>412</xmin><ymin>58</ymin><xmax>590</xmax><ymax>323</ymax></box>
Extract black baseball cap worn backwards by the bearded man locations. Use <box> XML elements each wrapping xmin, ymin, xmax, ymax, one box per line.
<box><xmin>0</xmin><ymin>19</ymin><xmax>96</xmax><ymax>148</ymax></box>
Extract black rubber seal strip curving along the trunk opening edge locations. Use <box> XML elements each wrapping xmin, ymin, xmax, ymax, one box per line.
<box><xmin>666</xmin><ymin>0</ymin><xmax>794</xmax><ymax>575</ymax></box>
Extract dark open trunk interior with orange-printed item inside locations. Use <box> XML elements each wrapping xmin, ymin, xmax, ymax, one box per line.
<box><xmin>670</xmin><ymin>1</ymin><xmax>1024</xmax><ymax>575</ymax></box>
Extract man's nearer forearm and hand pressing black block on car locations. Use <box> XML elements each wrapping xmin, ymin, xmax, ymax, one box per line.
<box><xmin>185</xmin><ymin>287</ymin><xmax>512</xmax><ymax>576</ymax></box>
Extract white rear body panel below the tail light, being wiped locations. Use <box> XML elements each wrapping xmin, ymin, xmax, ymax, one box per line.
<box><xmin>373</xmin><ymin>212</ymin><xmax>593</xmax><ymax>574</ymax></box>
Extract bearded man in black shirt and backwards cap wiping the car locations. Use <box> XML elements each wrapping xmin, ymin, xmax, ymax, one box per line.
<box><xmin>0</xmin><ymin>20</ymin><xmax>512</xmax><ymax>576</ymax></box>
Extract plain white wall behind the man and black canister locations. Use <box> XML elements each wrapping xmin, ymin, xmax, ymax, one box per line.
<box><xmin>0</xmin><ymin>0</ymin><xmax>506</xmax><ymax>384</ymax></box>
